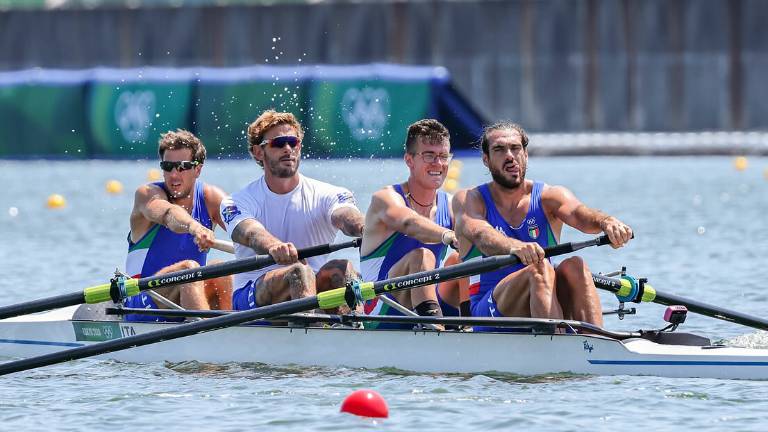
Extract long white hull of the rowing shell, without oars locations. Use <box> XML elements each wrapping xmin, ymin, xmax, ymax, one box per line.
<box><xmin>0</xmin><ymin>306</ymin><xmax>768</xmax><ymax>379</ymax></box>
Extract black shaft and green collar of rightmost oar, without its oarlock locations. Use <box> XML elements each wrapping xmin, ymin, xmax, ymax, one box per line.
<box><xmin>592</xmin><ymin>274</ymin><xmax>768</xmax><ymax>330</ymax></box>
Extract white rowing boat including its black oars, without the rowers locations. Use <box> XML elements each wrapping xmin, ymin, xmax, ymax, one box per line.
<box><xmin>0</xmin><ymin>236</ymin><xmax>768</xmax><ymax>379</ymax></box>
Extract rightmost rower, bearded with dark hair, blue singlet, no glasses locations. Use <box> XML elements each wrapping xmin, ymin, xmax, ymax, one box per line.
<box><xmin>453</xmin><ymin>122</ymin><xmax>632</xmax><ymax>331</ymax></box>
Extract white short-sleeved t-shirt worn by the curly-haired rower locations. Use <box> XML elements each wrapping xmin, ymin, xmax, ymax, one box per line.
<box><xmin>220</xmin><ymin>174</ymin><xmax>356</xmax><ymax>289</ymax></box>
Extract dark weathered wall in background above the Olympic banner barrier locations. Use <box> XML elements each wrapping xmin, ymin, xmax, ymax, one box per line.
<box><xmin>0</xmin><ymin>0</ymin><xmax>768</xmax><ymax>131</ymax></box>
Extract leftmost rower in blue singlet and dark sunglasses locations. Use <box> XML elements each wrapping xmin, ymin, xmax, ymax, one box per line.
<box><xmin>125</xmin><ymin>130</ymin><xmax>232</xmax><ymax>321</ymax></box>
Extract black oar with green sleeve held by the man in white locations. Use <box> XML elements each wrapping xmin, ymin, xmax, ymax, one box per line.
<box><xmin>0</xmin><ymin>239</ymin><xmax>360</xmax><ymax>319</ymax></box>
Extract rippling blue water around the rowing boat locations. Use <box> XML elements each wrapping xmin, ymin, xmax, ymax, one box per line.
<box><xmin>0</xmin><ymin>157</ymin><xmax>768</xmax><ymax>431</ymax></box>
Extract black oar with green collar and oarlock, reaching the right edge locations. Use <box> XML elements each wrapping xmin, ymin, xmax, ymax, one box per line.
<box><xmin>592</xmin><ymin>274</ymin><xmax>768</xmax><ymax>330</ymax></box>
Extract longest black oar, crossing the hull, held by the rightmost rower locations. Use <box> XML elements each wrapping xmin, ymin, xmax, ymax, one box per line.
<box><xmin>0</xmin><ymin>236</ymin><xmax>610</xmax><ymax>375</ymax></box>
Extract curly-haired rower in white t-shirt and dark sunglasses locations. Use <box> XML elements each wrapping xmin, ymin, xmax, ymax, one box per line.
<box><xmin>221</xmin><ymin>110</ymin><xmax>363</xmax><ymax>312</ymax></box>
